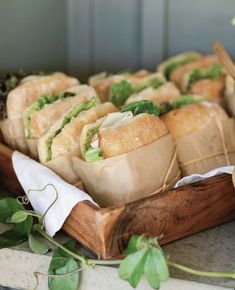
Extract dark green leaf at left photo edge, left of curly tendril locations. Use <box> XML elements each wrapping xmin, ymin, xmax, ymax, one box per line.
<box><xmin>0</xmin><ymin>198</ymin><xmax>24</xmax><ymax>223</ymax></box>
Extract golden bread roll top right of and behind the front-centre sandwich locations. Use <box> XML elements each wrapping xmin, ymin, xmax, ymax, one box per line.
<box><xmin>161</xmin><ymin>102</ymin><xmax>229</xmax><ymax>140</ymax></box>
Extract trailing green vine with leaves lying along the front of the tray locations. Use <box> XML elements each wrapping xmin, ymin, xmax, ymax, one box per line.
<box><xmin>0</xmin><ymin>198</ymin><xmax>235</xmax><ymax>290</ymax></box>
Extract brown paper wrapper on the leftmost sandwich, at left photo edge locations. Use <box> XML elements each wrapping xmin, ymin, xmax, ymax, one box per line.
<box><xmin>0</xmin><ymin>118</ymin><xmax>28</xmax><ymax>154</ymax></box>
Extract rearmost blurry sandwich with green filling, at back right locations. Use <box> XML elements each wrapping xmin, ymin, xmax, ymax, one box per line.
<box><xmin>157</xmin><ymin>51</ymin><xmax>202</xmax><ymax>80</ymax></box>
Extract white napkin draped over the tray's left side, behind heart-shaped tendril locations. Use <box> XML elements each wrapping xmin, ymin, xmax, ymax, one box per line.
<box><xmin>12</xmin><ymin>151</ymin><xmax>95</xmax><ymax>237</ymax></box>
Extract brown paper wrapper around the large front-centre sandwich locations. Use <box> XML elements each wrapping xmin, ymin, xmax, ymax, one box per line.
<box><xmin>72</xmin><ymin>134</ymin><xmax>180</xmax><ymax>206</ymax></box>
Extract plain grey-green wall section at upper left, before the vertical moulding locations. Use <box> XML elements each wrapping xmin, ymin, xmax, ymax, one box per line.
<box><xmin>0</xmin><ymin>0</ymin><xmax>67</xmax><ymax>72</ymax></box>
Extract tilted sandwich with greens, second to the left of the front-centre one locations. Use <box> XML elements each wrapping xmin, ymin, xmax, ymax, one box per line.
<box><xmin>24</xmin><ymin>85</ymin><xmax>96</xmax><ymax>158</ymax></box>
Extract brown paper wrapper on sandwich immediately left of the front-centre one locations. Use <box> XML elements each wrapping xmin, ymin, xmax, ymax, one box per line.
<box><xmin>43</xmin><ymin>147</ymin><xmax>81</xmax><ymax>184</ymax></box>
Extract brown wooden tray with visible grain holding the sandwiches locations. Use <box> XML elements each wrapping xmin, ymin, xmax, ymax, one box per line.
<box><xmin>0</xmin><ymin>143</ymin><xmax>235</xmax><ymax>259</ymax></box>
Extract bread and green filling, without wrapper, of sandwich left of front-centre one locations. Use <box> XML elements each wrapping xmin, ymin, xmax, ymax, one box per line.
<box><xmin>38</xmin><ymin>97</ymin><xmax>117</xmax><ymax>163</ymax></box>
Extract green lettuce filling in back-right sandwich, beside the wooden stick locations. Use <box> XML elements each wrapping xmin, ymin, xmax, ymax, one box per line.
<box><xmin>184</xmin><ymin>63</ymin><xmax>223</xmax><ymax>92</ymax></box>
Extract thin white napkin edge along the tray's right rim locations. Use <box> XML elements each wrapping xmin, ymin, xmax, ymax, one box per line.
<box><xmin>175</xmin><ymin>166</ymin><xmax>234</xmax><ymax>188</ymax></box>
